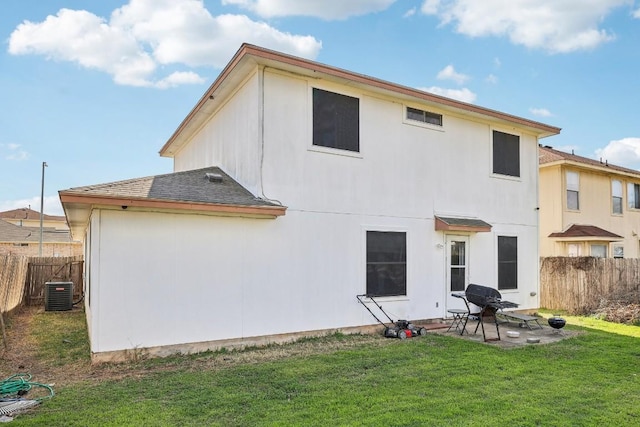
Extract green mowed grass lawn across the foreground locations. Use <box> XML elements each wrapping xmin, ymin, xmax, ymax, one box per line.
<box><xmin>6</xmin><ymin>313</ymin><xmax>640</xmax><ymax>427</ymax></box>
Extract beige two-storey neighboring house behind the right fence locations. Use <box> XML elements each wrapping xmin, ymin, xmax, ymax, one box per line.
<box><xmin>539</xmin><ymin>146</ymin><xmax>640</xmax><ymax>258</ymax></box>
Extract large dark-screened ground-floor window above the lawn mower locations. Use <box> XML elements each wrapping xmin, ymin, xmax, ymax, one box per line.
<box><xmin>367</xmin><ymin>231</ymin><xmax>407</xmax><ymax>296</ymax></box>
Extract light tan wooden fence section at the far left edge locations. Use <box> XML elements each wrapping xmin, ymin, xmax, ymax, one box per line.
<box><xmin>0</xmin><ymin>255</ymin><xmax>29</xmax><ymax>313</ymax></box>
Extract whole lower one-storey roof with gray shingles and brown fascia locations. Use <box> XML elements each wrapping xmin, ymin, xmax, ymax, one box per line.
<box><xmin>59</xmin><ymin>167</ymin><xmax>286</xmax><ymax>239</ymax></box>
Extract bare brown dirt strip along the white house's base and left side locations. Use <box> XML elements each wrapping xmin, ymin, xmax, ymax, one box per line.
<box><xmin>0</xmin><ymin>307</ymin><xmax>392</xmax><ymax>386</ymax></box>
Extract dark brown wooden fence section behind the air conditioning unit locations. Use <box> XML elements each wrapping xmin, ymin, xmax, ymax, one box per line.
<box><xmin>26</xmin><ymin>256</ymin><xmax>84</xmax><ymax>305</ymax></box>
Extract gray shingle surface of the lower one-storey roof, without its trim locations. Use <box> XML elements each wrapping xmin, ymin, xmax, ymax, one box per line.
<box><xmin>62</xmin><ymin>167</ymin><xmax>280</xmax><ymax>206</ymax></box>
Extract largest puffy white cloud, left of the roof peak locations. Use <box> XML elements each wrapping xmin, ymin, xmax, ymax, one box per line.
<box><xmin>9</xmin><ymin>0</ymin><xmax>322</xmax><ymax>88</ymax></box>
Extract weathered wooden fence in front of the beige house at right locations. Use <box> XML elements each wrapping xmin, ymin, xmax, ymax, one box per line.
<box><xmin>540</xmin><ymin>257</ymin><xmax>640</xmax><ymax>314</ymax></box>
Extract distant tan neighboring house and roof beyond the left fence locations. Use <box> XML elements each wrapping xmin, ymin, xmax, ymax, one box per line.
<box><xmin>0</xmin><ymin>208</ymin><xmax>83</xmax><ymax>257</ymax></box>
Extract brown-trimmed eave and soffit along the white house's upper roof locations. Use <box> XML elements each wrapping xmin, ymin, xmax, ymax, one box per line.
<box><xmin>160</xmin><ymin>43</ymin><xmax>561</xmax><ymax>157</ymax></box>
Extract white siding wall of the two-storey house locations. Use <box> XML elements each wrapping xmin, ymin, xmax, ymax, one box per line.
<box><xmin>92</xmin><ymin>67</ymin><xmax>538</xmax><ymax>351</ymax></box>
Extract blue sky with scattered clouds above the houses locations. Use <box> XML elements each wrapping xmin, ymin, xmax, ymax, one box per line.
<box><xmin>0</xmin><ymin>0</ymin><xmax>640</xmax><ymax>215</ymax></box>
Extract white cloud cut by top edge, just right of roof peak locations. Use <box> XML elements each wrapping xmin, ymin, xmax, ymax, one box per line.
<box><xmin>222</xmin><ymin>0</ymin><xmax>396</xmax><ymax>20</ymax></box>
